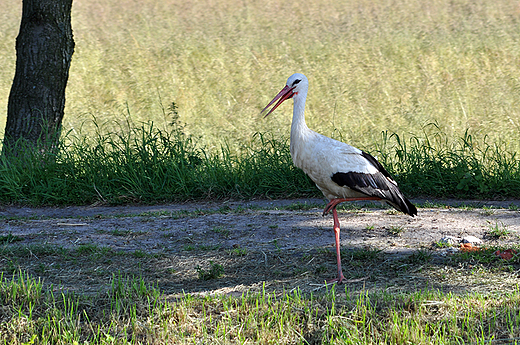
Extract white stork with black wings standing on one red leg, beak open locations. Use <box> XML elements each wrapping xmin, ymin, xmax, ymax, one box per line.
<box><xmin>262</xmin><ymin>73</ymin><xmax>417</xmax><ymax>284</ymax></box>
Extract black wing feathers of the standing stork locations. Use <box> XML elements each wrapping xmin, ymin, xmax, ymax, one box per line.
<box><xmin>331</xmin><ymin>152</ymin><xmax>417</xmax><ymax>216</ymax></box>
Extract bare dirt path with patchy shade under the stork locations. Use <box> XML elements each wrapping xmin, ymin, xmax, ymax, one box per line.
<box><xmin>0</xmin><ymin>199</ymin><xmax>520</xmax><ymax>296</ymax></box>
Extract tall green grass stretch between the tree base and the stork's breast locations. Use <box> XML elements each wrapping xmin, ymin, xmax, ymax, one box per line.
<box><xmin>0</xmin><ymin>118</ymin><xmax>316</xmax><ymax>204</ymax></box>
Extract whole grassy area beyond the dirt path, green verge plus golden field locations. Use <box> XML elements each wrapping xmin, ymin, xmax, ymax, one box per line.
<box><xmin>0</xmin><ymin>0</ymin><xmax>520</xmax><ymax>204</ymax></box>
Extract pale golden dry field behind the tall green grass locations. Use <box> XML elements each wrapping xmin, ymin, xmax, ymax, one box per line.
<box><xmin>0</xmin><ymin>0</ymin><xmax>520</xmax><ymax>150</ymax></box>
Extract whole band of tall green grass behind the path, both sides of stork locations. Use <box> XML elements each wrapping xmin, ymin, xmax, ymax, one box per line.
<box><xmin>0</xmin><ymin>122</ymin><xmax>520</xmax><ymax>205</ymax></box>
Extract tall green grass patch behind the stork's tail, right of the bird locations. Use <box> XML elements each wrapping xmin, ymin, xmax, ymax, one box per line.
<box><xmin>374</xmin><ymin>124</ymin><xmax>520</xmax><ymax>198</ymax></box>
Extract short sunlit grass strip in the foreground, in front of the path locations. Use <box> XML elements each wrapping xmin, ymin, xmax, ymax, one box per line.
<box><xmin>0</xmin><ymin>272</ymin><xmax>520</xmax><ymax>345</ymax></box>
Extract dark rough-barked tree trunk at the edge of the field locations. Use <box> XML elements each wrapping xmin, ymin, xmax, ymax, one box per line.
<box><xmin>2</xmin><ymin>0</ymin><xmax>74</xmax><ymax>156</ymax></box>
